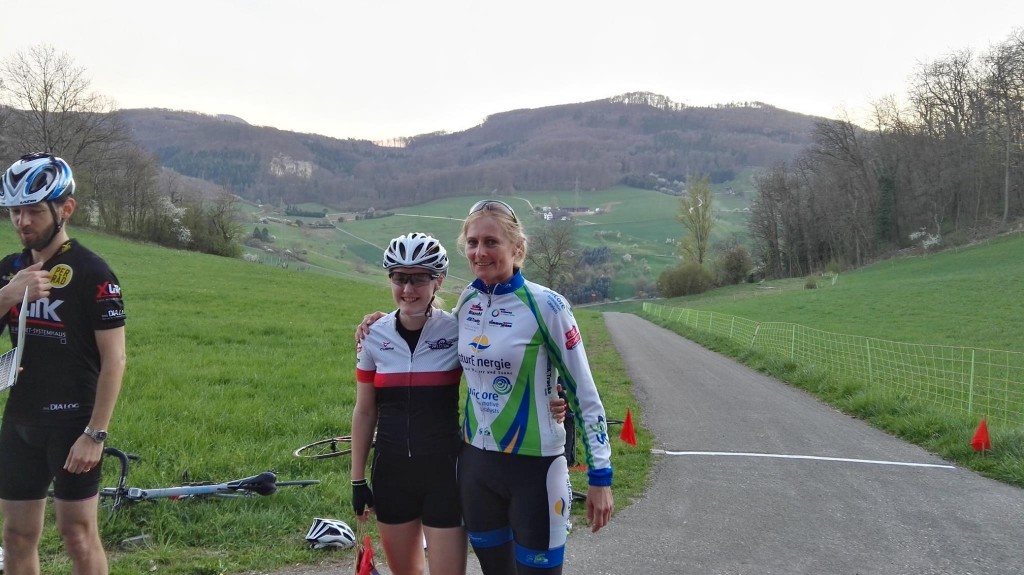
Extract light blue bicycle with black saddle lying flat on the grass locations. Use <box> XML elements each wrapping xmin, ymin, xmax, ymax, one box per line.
<box><xmin>99</xmin><ymin>447</ymin><xmax>319</xmax><ymax>515</ymax></box>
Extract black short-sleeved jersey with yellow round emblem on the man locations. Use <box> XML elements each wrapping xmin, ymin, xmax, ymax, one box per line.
<box><xmin>0</xmin><ymin>239</ymin><xmax>125</xmax><ymax>425</ymax></box>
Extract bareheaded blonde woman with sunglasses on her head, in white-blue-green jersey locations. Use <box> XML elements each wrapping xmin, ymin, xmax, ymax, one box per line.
<box><xmin>456</xmin><ymin>200</ymin><xmax>613</xmax><ymax>575</ymax></box>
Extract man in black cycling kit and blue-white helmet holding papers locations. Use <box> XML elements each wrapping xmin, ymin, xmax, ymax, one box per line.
<box><xmin>0</xmin><ymin>153</ymin><xmax>125</xmax><ymax>575</ymax></box>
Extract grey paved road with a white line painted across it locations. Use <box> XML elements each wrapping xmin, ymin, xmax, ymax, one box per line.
<box><xmin>266</xmin><ymin>313</ymin><xmax>1024</xmax><ymax>575</ymax></box>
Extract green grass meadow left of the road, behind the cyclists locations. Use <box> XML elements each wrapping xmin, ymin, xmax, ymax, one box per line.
<box><xmin>0</xmin><ymin>229</ymin><xmax>650</xmax><ymax>575</ymax></box>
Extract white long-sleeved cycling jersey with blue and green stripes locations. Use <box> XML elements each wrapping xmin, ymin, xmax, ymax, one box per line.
<box><xmin>456</xmin><ymin>270</ymin><xmax>612</xmax><ymax>485</ymax></box>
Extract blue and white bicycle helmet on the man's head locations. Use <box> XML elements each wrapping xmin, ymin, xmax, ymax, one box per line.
<box><xmin>0</xmin><ymin>152</ymin><xmax>75</xmax><ymax>208</ymax></box>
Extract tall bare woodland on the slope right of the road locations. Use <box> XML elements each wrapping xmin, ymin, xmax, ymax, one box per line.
<box><xmin>750</xmin><ymin>30</ymin><xmax>1024</xmax><ymax>277</ymax></box>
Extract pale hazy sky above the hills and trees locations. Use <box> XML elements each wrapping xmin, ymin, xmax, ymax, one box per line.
<box><xmin>0</xmin><ymin>0</ymin><xmax>1024</xmax><ymax>140</ymax></box>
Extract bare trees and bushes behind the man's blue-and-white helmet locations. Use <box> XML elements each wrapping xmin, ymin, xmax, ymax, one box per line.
<box><xmin>0</xmin><ymin>45</ymin><xmax>241</xmax><ymax>257</ymax></box>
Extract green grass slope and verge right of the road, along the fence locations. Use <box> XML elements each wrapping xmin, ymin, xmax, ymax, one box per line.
<box><xmin>626</xmin><ymin>230</ymin><xmax>1024</xmax><ymax>487</ymax></box>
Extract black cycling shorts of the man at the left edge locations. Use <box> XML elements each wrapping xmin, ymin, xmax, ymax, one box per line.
<box><xmin>0</xmin><ymin>419</ymin><xmax>102</xmax><ymax>501</ymax></box>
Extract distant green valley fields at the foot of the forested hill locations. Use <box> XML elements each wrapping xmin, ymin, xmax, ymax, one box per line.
<box><xmin>237</xmin><ymin>183</ymin><xmax>749</xmax><ymax>298</ymax></box>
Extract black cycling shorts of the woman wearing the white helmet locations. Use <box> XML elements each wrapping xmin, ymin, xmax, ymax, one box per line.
<box><xmin>371</xmin><ymin>451</ymin><xmax>462</xmax><ymax>528</ymax></box>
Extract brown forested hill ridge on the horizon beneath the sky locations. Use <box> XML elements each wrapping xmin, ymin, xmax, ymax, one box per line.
<box><xmin>122</xmin><ymin>92</ymin><xmax>820</xmax><ymax>209</ymax></box>
